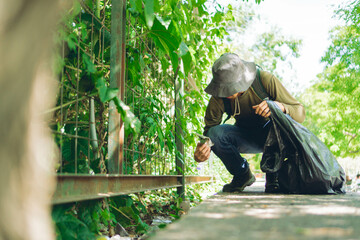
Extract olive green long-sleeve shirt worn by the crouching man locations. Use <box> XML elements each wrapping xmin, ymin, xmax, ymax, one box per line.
<box><xmin>204</xmin><ymin>71</ymin><xmax>305</xmax><ymax>135</ymax></box>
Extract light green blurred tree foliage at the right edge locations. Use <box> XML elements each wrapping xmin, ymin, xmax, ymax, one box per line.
<box><xmin>303</xmin><ymin>0</ymin><xmax>360</xmax><ymax>157</ymax></box>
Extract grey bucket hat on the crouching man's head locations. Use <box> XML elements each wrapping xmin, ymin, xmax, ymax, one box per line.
<box><xmin>205</xmin><ymin>53</ymin><xmax>256</xmax><ymax>97</ymax></box>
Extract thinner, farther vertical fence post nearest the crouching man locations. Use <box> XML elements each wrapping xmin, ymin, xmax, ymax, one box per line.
<box><xmin>175</xmin><ymin>70</ymin><xmax>185</xmax><ymax>199</ymax></box>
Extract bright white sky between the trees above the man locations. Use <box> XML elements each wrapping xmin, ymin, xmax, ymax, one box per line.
<box><xmin>215</xmin><ymin>0</ymin><xmax>344</xmax><ymax>92</ymax></box>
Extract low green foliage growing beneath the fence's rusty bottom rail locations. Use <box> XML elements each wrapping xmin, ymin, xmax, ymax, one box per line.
<box><xmin>52</xmin><ymin>189</ymin><xmax>200</xmax><ymax>240</ymax></box>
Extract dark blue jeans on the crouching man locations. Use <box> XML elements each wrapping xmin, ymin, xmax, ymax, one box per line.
<box><xmin>207</xmin><ymin>122</ymin><xmax>270</xmax><ymax>175</ymax></box>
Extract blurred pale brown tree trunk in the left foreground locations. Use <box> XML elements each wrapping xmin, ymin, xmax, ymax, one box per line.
<box><xmin>0</xmin><ymin>0</ymin><xmax>64</xmax><ymax>240</ymax></box>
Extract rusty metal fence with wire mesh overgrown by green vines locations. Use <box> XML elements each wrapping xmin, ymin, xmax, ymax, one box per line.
<box><xmin>49</xmin><ymin>0</ymin><xmax>211</xmax><ymax>203</ymax></box>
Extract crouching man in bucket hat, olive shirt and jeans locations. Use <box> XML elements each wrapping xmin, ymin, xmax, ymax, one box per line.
<box><xmin>194</xmin><ymin>53</ymin><xmax>305</xmax><ymax>193</ymax></box>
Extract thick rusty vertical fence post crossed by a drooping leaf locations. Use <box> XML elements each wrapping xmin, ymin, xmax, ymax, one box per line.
<box><xmin>108</xmin><ymin>0</ymin><xmax>126</xmax><ymax>174</ymax></box>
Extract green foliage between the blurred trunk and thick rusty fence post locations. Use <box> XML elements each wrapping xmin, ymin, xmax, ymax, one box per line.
<box><xmin>51</xmin><ymin>0</ymin><xmax>140</xmax><ymax>173</ymax></box>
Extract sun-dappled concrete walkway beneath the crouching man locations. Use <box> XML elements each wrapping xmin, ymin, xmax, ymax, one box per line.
<box><xmin>150</xmin><ymin>181</ymin><xmax>360</xmax><ymax>240</ymax></box>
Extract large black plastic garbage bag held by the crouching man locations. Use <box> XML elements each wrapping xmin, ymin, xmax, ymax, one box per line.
<box><xmin>260</xmin><ymin>101</ymin><xmax>345</xmax><ymax>194</ymax></box>
